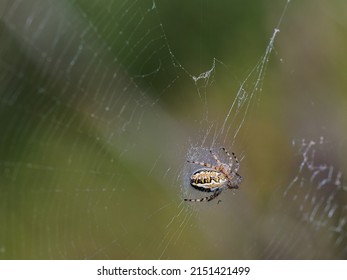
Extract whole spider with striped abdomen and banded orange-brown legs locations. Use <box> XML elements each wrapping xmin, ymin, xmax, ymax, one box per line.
<box><xmin>184</xmin><ymin>148</ymin><xmax>242</xmax><ymax>202</ymax></box>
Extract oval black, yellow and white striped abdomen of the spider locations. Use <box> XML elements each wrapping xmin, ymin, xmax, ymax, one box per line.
<box><xmin>190</xmin><ymin>169</ymin><xmax>228</xmax><ymax>192</ymax></box>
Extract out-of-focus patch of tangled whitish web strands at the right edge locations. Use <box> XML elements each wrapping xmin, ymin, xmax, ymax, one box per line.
<box><xmin>283</xmin><ymin>137</ymin><xmax>347</xmax><ymax>258</ymax></box>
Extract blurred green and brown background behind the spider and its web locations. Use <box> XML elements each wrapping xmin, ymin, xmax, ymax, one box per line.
<box><xmin>0</xmin><ymin>0</ymin><xmax>347</xmax><ymax>259</ymax></box>
